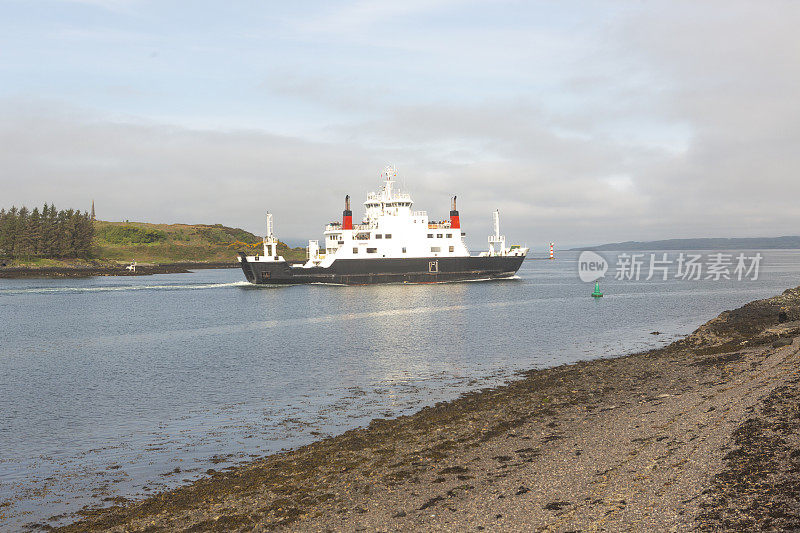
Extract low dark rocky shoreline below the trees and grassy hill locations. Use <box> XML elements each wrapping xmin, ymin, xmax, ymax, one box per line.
<box><xmin>0</xmin><ymin>261</ymin><xmax>239</xmax><ymax>279</ymax></box>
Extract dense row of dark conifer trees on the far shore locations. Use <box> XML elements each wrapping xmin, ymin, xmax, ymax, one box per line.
<box><xmin>0</xmin><ymin>204</ymin><xmax>94</xmax><ymax>259</ymax></box>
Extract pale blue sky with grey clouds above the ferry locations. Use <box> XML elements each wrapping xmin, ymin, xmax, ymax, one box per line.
<box><xmin>0</xmin><ymin>0</ymin><xmax>800</xmax><ymax>247</ymax></box>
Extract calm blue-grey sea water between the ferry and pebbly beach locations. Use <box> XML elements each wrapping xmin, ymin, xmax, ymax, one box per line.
<box><xmin>0</xmin><ymin>251</ymin><xmax>800</xmax><ymax>530</ymax></box>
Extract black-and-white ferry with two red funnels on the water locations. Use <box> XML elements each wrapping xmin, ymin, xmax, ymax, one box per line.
<box><xmin>238</xmin><ymin>166</ymin><xmax>528</xmax><ymax>285</ymax></box>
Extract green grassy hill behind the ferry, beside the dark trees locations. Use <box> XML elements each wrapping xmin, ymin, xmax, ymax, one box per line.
<box><xmin>92</xmin><ymin>220</ymin><xmax>306</xmax><ymax>263</ymax></box>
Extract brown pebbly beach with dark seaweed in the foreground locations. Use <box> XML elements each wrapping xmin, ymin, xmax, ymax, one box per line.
<box><xmin>54</xmin><ymin>288</ymin><xmax>800</xmax><ymax>531</ymax></box>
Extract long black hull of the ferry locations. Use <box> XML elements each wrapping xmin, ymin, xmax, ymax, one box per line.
<box><xmin>239</xmin><ymin>254</ymin><xmax>525</xmax><ymax>285</ymax></box>
